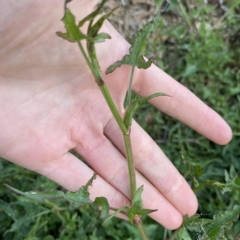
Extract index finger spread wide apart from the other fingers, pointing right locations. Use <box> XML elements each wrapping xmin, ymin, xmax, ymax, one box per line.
<box><xmin>133</xmin><ymin>65</ymin><xmax>232</xmax><ymax>144</ymax></box>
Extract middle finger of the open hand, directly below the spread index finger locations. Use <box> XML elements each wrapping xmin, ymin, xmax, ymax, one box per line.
<box><xmin>105</xmin><ymin>117</ymin><xmax>198</xmax><ymax>217</ymax></box>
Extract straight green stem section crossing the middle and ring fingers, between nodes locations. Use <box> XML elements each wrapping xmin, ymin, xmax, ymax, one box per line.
<box><xmin>123</xmin><ymin>131</ymin><xmax>136</xmax><ymax>200</ymax></box>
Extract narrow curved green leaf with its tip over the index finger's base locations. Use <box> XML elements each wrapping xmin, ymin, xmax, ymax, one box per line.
<box><xmin>124</xmin><ymin>93</ymin><xmax>169</xmax><ymax>130</ymax></box>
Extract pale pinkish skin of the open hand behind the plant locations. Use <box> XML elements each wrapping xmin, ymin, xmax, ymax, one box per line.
<box><xmin>0</xmin><ymin>0</ymin><xmax>232</xmax><ymax>229</ymax></box>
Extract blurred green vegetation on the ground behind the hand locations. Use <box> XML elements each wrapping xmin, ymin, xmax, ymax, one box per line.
<box><xmin>0</xmin><ymin>0</ymin><xmax>240</xmax><ymax>240</ymax></box>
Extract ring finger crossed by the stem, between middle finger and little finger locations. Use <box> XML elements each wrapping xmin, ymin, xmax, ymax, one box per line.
<box><xmin>76</xmin><ymin>131</ymin><xmax>182</xmax><ymax>229</ymax></box>
